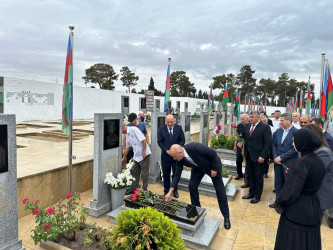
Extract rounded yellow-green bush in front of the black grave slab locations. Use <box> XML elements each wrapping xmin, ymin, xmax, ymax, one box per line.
<box><xmin>104</xmin><ymin>207</ymin><xmax>185</xmax><ymax>250</ymax></box>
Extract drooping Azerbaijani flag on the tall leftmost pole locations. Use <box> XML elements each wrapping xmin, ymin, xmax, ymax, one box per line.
<box><xmin>62</xmin><ymin>35</ymin><xmax>73</xmax><ymax>135</ymax></box>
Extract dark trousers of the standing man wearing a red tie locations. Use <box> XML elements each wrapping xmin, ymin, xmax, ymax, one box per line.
<box><xmin>246</xmin><ymin>156</ymin><xmax>264</xmax><ymax>199</ymax></box>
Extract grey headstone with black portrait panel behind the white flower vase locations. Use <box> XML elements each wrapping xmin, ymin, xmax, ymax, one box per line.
<box><xmin>84</xmin><ymin>113</ymin><xmax>123</xmax><ymax>217</ymax></box>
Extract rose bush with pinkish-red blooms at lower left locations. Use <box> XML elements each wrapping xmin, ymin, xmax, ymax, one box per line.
<box><xmin>23</xmin><ymin>193</ymin><xmax>86</xmax><ymax>245</ymax></box>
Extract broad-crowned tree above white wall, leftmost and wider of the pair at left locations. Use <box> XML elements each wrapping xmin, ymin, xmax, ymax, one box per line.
<box><xmin>82</xmin><ymin>63</ymin><xmax>119</xmax><ymax>90</ymax></box>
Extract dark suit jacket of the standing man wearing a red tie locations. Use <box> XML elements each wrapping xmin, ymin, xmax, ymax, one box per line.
<box><xmin>244</xmin><ymin>122</ymin><xmax>272</xmax><ymax>162</ymax></box>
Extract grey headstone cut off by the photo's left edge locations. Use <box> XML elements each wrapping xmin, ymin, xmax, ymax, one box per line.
<box><xmin>0</xmin><ymin>115</ymin><xmax>24</xmax><ymax>250</ymax></box>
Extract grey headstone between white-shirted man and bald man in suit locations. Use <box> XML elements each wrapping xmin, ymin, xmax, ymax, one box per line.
<box><xmin>149</xmin><ymin>112</ymin><xmax>165</xmax><ymax>183</ymax></box>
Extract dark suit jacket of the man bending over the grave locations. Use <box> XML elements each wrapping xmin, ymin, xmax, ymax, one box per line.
<box><xmin>171</xmin><ymin>142</ymin><xmax>222</xmax><ymax>188</ymax></box>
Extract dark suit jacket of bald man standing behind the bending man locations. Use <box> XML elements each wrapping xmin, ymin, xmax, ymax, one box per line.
<box><xmin>157</xmin><ymin>124</ymin><xmax>185</xmax><ymax>161</ymax></box>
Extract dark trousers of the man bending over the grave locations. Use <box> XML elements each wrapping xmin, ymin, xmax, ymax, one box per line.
<box><xmin>188</xmin><ymin>168</ymin><xmax>229</xmax><ymax>218</ymax></box>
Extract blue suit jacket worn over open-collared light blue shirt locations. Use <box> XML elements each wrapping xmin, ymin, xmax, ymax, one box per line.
<box><xmin>272</xmin><ymin>126</ymin><xmax>298</xmax><ymax>167</ymax></box>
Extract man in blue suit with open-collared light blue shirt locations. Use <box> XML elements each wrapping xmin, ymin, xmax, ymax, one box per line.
<box><xmin>269</xmin><ymin>113</ymin><xmax>298</xmax><ymax>208</ymax></box>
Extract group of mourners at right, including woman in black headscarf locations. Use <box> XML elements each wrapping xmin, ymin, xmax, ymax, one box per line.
<box><xmin>234</xmin><ymin>110</ymin><xmax>333</xmax><ymax>249</ymax></box>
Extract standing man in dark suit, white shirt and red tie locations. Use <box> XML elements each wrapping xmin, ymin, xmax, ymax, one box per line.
<box><xmin>242</xmin><ymin>110</ymin><xmax>272</xmax><ymax>203</ymax></box>
